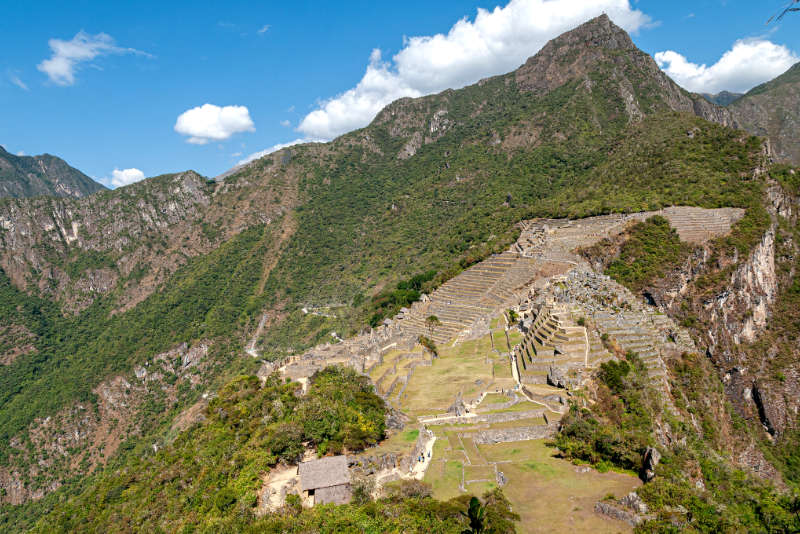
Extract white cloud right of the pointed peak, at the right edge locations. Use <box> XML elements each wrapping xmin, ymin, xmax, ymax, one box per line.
<box><xmin>654</xmin><ymin>39</ymin><xmax>800</xmax><ymax>93</ymax></box>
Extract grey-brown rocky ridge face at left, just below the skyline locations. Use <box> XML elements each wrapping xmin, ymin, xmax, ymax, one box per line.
<box><xmin>0</xmin><ymin>163</ymin><xmax>296</xmax><ymax>312</ymax></box>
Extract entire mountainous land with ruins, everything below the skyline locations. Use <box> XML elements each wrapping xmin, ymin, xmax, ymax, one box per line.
<box><xmin>0</xmin><ymin>15</ymin><xmax>800</xmax><ymax>533</ymax></box>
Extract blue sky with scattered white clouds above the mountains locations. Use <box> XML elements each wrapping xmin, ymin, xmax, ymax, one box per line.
<box><xmin>0</xmin><ymin>0</ymin><xmax>800</xmax><ymax>185</ymax></box>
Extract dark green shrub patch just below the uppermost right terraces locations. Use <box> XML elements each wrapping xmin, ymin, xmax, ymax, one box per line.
<box><xmin>606</xmin><ymin>215</ymin><xmax>690</xmax><ymax>290</ymax></box>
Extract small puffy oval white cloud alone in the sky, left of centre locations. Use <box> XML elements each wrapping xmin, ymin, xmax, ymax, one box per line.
<box><xmin>175</xmin><ymin>104</ymin><xmax>256</xmax><ymax>145</ymax></box>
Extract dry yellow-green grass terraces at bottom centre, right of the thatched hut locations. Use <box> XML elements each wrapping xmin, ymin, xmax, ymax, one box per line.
<box><xmin>418</xmin><ymin>386</ymin><xmax>639</xmax><ymax>532</ymax></box>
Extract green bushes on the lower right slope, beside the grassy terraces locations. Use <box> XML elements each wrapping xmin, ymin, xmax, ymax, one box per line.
<box><xmin>555</xmin><ymin>354</ymin><xmax>800</xmax><ymax>533</ymax></box>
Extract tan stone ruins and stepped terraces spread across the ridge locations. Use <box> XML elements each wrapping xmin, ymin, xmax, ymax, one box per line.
<box><xmin>268</xmin><ymin>207</ymin><xmax>743</xmax><ymax>410</ymax></box>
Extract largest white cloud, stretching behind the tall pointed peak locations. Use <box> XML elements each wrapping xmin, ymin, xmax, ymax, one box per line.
<box><xmin>298</xmin><ymin>0</ymin><xmax>651</xmax><ymax>139</ymax></box>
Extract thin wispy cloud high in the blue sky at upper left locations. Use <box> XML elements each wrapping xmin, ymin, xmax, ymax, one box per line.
<box><xmin>36</xmin><ymin>31</ymin><xmax>152</xmax><ymax>85</ymax></box>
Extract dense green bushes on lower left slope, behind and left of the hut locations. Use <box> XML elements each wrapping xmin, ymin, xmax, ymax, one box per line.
<box><xmin>24</xmin><ymin>367</ymin><xmax>385</xmax><ymax>532</ymax></box>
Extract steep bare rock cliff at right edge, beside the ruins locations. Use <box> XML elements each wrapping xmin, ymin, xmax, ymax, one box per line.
<box><xmin>645</xmin><ymin>175</ymin><xmax>800</xmax><ymax>444</ymax></box>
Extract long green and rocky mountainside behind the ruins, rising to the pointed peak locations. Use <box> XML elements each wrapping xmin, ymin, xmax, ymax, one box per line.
<box><xmin>0</xmin><ymin>16</ymin><xmax>792</xmax><ymax>532</ymax></box>
